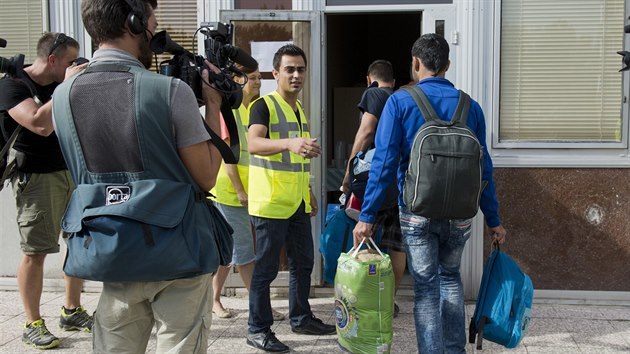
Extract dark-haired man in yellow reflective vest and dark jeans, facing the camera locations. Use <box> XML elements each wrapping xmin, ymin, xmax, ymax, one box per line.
<box><xmin>247</xmin><ymin>44</ymin><xmax>335</xmax><ymax>352</ymax></box>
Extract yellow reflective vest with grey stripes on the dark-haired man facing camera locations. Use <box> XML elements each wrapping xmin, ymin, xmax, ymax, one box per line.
<box><xmin>248</xmin><ymin>91</ymin><xmax>311</xmax><ymax>219</ymax></box>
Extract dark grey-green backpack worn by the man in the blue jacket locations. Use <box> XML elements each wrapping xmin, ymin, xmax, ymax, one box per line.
<box><xmin>402</xmin><ymin>86</ymin><xmax>484</xmax><ymax>219</ymax></box>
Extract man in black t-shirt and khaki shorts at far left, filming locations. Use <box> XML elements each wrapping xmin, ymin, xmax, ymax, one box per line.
<box><xmin>0</xmin><ymin>33</ymin><xmax>92</xmax><ymax>349</ymax></box>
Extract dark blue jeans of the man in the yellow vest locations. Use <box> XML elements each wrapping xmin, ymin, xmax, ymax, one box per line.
<box><xmin>248</xmin><ymin>203</ymin><xmax>314</xmax><ymax>333</ymax></box>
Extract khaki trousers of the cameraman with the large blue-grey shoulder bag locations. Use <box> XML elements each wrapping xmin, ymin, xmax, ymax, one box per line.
<box><xmin>92</xmin><ymin>274</ymin><xmax>212</xmax><ymax>354</ymax></box>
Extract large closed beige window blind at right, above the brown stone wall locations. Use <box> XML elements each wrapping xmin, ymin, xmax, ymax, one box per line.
<box><xmin>499</xmin><ymin>0</ymin><xmax>624</xmax><ymax>142</ymax></box>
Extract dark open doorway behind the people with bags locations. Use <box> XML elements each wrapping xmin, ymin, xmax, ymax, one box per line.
<box><xmin>325</xmin><ymin>12</ymin><xmax>422</xmax><ymax>203</ymax></box>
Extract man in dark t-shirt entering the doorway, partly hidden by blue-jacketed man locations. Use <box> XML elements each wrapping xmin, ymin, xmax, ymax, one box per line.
<box><xmin>341</xmin><ymin>59</ymin><xmax>407</xmax><ymax>317</ymax></box>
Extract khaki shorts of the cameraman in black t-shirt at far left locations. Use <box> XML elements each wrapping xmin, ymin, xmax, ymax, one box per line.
<box><xmin>11</xmin><ymin>170</ymin><xmax>74</xmax><ymax>255</ymax></box>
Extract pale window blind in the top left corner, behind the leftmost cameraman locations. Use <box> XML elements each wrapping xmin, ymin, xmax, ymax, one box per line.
<box><xmin>0</xmin><ymin>0</ymin><xmax>44</xmax><ymax>63</ymax></box>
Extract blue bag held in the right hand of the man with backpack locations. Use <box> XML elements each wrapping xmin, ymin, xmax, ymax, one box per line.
<box><xmin>468</xmin><ymin>245</ymin><xmax>534</xmax><ymax>349</ymax></box>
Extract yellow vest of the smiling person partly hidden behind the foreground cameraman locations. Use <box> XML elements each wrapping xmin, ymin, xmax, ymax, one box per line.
<box><xmin>210</xmin><ymin>104</ymin><xmax>249</xmax><ymax>207</ymax></box>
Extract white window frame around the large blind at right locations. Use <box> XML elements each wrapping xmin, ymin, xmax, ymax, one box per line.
<box><xmin>487</xmin><ymin>0</ymin><xmax>630</xmax><ymax>167</ymax></box>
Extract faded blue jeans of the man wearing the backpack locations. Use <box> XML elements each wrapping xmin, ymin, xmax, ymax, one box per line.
<box><xmin>400</xmin><ymin>208</ymin><xmax>472</xmax><ymax>354</ymax></box>
